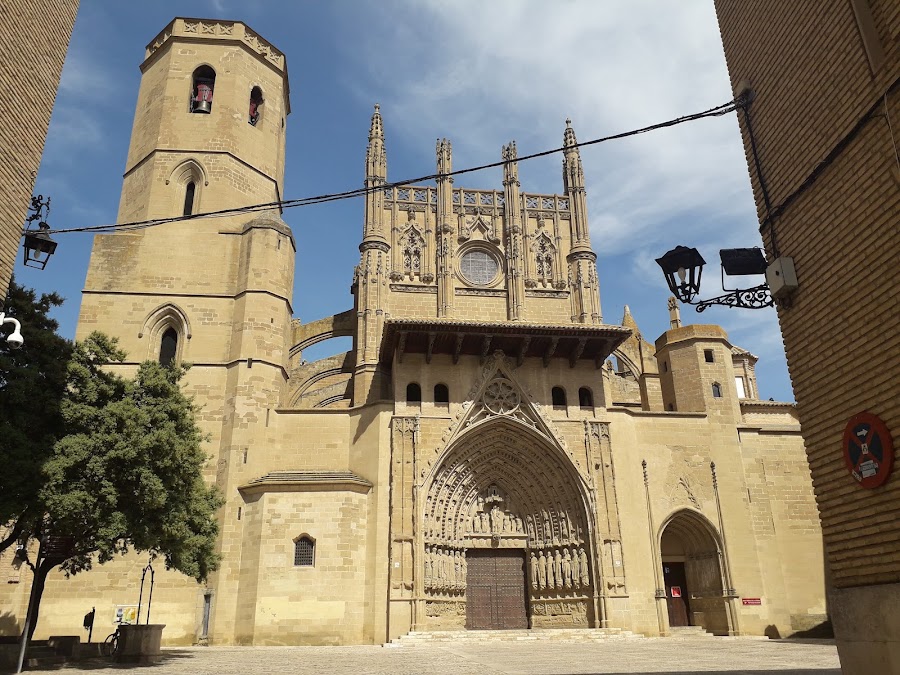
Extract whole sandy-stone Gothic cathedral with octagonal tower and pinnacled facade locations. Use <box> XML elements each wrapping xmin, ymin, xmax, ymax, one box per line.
<box><xmin>0</xmin><ymin>18</ymin><xmax>826</xmax><ymax>645</ymax></box>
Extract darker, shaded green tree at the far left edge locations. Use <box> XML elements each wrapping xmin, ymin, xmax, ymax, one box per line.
<box><xmin>0</xmin><ymin>280</ymin><xmax>72</xmax><ymax>552</ymax></box>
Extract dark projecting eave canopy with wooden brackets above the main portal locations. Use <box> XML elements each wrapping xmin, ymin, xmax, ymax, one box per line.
<box><xmin>380</xmin><ymin>319</ymin><xmax>631</xmax><ymax>368</ymax></box>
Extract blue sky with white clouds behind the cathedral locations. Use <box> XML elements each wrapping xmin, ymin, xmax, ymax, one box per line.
<box><xmin>16</xmin><ymin>0</ymin><xmax>793</xmax><ymax>400</ymax></box>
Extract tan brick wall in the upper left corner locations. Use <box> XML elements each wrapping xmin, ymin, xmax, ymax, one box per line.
<box><xmin>0</xmin><ymin>0</ymin><xmax>78</xmax><ymax>298</ymax></box>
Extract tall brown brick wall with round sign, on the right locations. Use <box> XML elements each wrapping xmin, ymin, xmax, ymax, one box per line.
<box><xmin>715</xmin><ymin>0</ymin><xmax>900</xmax><ymax>672</ymax></box>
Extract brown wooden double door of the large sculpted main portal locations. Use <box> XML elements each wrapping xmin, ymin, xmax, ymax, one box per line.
<box><xmin>466</xmin><ymin>549</ymin><xmax>528</xmax><ymax>630</ymax></box>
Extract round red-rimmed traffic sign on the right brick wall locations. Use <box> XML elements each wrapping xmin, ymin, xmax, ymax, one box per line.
<box><xmin>844</xmin><ymin>412</ymin><xmax>894</xmax><ymax>488</ymax></box>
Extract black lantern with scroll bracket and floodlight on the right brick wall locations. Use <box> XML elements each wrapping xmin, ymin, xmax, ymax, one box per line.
<box><xmin>656</xmin><ymin>246</ymin><xmax>775</xmax><ymax>312</ymax></box>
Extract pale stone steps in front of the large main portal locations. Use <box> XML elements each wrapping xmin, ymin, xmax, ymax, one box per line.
<box><xmin>384</xmin><ymin>628</ymin><xmax>643</xmax><ymax>647</ymax></box>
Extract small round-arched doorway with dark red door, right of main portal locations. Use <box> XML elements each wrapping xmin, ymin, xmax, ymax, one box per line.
<box><xmin>659</xmin><ymin>509</ymin><xmax>729</xmax><ymax>635</ymax></box>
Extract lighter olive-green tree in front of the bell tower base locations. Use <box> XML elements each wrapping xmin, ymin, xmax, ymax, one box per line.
<box><xmin>19</xmin><ymin>333</ymin><xmax>222</xmax><ymax>632</ymax></box>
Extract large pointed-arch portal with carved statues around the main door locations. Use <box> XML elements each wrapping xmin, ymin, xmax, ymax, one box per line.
<box><xmin>421</xmin><ymin>414</ymin><xmax>595</xmax><ymax>629</ymax></box>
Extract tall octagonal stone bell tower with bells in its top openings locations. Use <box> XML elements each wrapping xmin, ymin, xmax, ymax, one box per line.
<box><xmin>77</xmin><ymin>18</ymin><xmax>295</xmax><ymax>642</ymax></box>
